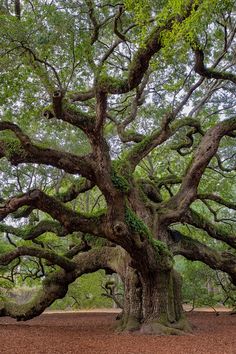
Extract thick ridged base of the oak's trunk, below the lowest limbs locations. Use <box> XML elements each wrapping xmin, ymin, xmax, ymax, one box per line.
<box><xmin>118</xmin><ymin>260</ymin><xmax>190</xmax><ymax>334</ymax></box>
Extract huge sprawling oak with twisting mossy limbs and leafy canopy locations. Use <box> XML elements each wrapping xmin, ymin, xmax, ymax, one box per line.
<box><xmin>0</xmin><ymin>0</ymin><xmax>236</xmax><ymax>334</ymax></box>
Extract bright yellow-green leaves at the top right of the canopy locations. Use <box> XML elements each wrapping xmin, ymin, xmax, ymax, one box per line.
<box><xmin>124</xmin><ymin>0</ymin><xmax>235</xmax><ymax>61</ymax></box>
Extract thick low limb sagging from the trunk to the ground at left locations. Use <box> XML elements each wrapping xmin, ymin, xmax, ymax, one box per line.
<box><xmin>0</xmin><ymin>247</ymin><xmax>125</xmax><ymax>321</ymax></box>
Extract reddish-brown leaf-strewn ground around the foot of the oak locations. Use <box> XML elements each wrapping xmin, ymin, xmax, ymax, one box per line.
<box><xmin>0</xmin><ymin>312</ymin><xmax>236</xmax><ymax>354</ymax></box>
